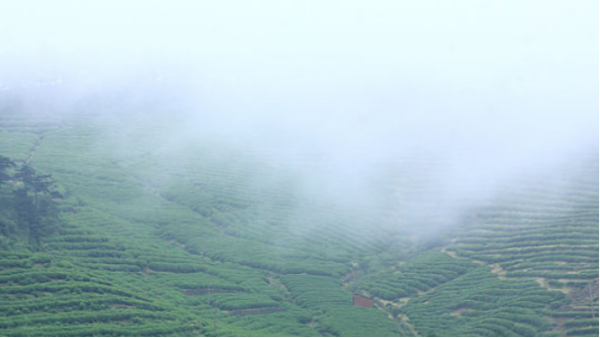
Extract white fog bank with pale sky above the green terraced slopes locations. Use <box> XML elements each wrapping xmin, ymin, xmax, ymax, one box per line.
<box><xmin>0</xmin><ymin>0</ymin><xmax>600</xmax><ymax>238</ymax></box>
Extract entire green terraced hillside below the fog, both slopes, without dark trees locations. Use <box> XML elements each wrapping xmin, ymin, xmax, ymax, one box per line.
<box><xmin>0</xmin><ymin>97</ymin><xmax>600</xmax><ymax>336</ymax></box>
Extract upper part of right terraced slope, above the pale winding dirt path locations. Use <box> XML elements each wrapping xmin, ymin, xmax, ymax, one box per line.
<box><xmin>449</xmin><ymin>156</ymin><xmax>600</xmax><ymax>336</ymax></box>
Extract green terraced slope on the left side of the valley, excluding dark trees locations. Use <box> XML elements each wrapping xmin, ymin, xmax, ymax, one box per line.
<box><xmin>0</xmin><ymin>97</ymin><xmax>408</xmax><ymax>336</ymax></box>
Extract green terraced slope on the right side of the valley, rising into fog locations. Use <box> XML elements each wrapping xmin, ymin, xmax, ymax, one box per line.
<box><xmin>355</xmin><ymin>156</ymin><xmax>600</xmax><ymax>336</ymax></box>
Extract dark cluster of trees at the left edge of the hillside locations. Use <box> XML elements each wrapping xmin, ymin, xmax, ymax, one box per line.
<box><xmin>0</xmin><ymin>155</ymin><xmax>62</xmax><ymax>246</ymax></box>
